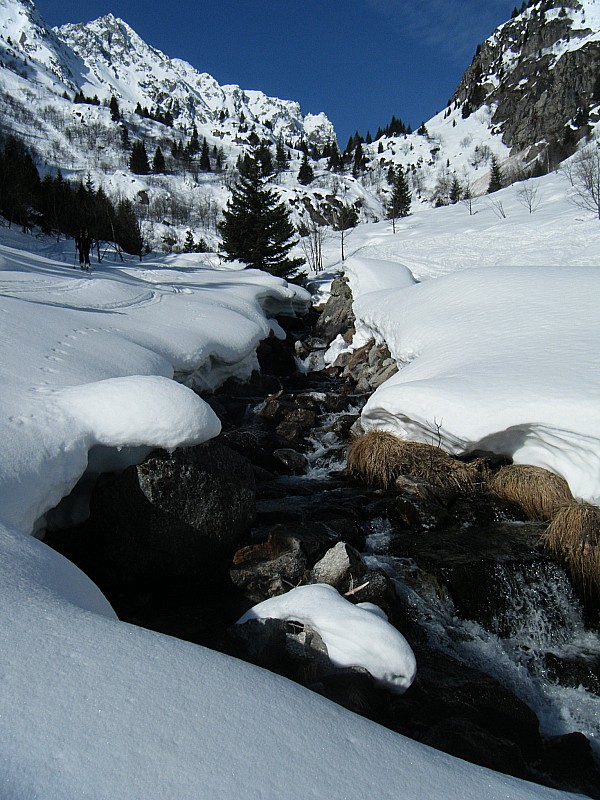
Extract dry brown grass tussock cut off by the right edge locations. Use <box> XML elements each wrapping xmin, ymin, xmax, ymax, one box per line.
<box><xmin>543</xmin><ymin>502</ymin><xmax>600</xmax><ymax>593</ymax></box>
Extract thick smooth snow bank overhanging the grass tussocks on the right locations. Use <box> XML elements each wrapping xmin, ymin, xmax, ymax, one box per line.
<box><xmin>348</xmin><ymin>262</ymin><xmax>600</xmax><ymax>502</ymax></box>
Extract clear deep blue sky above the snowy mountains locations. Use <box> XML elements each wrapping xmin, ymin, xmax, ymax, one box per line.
<box><xmin>34</xmin><ymin>0</ymin><xmax>520</xmax><ymax>147</ymax></box>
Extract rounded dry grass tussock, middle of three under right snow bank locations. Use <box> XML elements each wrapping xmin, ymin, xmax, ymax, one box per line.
<box><xmin>489</xmin><ymin>464</ymin><xmax>574</xmax><ymax>522</ymax></box>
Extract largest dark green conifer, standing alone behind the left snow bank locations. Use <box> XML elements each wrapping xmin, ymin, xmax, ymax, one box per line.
<box><xmin>218</xmin><ymin>161</ymin><xmax>304</xmax><ymax>278</ymax></box>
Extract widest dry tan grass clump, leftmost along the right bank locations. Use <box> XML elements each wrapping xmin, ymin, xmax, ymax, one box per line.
<box><xmin>347</xmin><ymin>431</ymin><xmax>478</xmax><ymax>492</ymax></box>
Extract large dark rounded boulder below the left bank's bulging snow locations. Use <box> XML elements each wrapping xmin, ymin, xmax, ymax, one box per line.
<box><xmin>45</xmin><ymin>440</ymin><xmax>255</xmax><ymax>586</ymax></box>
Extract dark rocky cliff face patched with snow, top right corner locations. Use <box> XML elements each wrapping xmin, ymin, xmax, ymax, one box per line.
<box><xmin>451</xmin><ymin>0</ymin><xmax>600</xmax><ymax>167</ymax></box>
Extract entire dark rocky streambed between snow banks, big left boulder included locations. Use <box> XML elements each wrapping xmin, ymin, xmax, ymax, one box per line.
<box><xmin>46</xmin><ymin>281</ymin><xmax>600</xmax><ymax>797</ymax></box>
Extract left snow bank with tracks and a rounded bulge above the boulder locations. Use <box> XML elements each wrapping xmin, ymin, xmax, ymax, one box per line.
<box><xmin>0</xmin><ymin>248</ymin><xmax>308</xmax><ymax>533</ymax></box>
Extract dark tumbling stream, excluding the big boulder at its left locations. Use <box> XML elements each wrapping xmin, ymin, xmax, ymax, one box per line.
<box><xmin>46</xmin><ymin>304</ymin><xmax>600</xmax><ymax>798</ymax></box>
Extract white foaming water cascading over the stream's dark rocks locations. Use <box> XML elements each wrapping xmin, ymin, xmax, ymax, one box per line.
<box><xmin>295</xmin><ymin>400</ymin><xmax>600</xmax><ymax>757</ymax></box>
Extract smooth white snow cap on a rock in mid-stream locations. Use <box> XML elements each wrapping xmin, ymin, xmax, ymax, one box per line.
<box><xmin>238</xmin><ymin>583</ymin><xmax>416</xmax><ymax>694</ymax></box>
